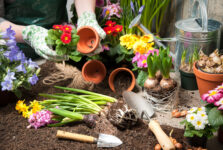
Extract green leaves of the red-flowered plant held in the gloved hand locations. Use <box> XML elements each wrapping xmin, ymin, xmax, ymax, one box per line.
<box><xmin>45</xmin><ymin>28</ymin><xmax>80</xmax><ymax>58</ymax></box>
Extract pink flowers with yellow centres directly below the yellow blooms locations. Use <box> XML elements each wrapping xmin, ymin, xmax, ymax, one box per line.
<box><xmin>132</xmin><ymin>49</ymin><xmax>159</xmax><ymax>68</ymax></box>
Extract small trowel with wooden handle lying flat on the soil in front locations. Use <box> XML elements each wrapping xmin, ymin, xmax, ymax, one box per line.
<box><xmin>56</xmin><ymin>130</ymin><xmax>122</xmax><ymax>147</ymax></box>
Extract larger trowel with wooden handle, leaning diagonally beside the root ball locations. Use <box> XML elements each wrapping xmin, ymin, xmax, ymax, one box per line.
<box><xmin>122</xmin><ymin>91</ymin><xmax>175</xmax><ymax>150</ymax></box>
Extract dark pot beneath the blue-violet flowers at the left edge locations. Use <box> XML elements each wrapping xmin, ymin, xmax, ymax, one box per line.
<box><xmin>0</xmin><ymin>91</ymin><xmax>18</xmax><ymax>106</ymax></box>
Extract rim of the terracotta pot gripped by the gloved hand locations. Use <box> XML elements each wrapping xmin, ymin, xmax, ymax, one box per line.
<box><xmin>77</xmin><ymin>26</ymin><xmax>100</xmax><ymax>54</ymax></box>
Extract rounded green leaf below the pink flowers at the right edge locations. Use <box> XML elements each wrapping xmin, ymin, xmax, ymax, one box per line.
<box><xmin>208</xmin><ymin>107</ymin><xmax>223</xmax><ymax>127</ymax></box>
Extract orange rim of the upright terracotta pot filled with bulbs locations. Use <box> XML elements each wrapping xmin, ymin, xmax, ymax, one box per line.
<box><xmin>193</xmin><ymin>62</ymin><xmax>223</xmax><ymax>81</ymax></box>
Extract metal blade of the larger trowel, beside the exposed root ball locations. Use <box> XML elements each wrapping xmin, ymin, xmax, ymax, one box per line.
<box><xmin>122</xmin><ymin>91</ymin><xmax>154</xmax><ymax>119</ymax></box>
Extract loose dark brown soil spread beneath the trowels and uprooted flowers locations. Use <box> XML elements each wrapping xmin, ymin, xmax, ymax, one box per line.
<box><xmin>0</xmin><ymin>62</ymin><xmax>193</xmax><ymax>150</ymax></box>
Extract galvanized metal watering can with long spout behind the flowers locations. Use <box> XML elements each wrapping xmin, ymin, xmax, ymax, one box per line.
<box><xmin>129</xmin><ymin>0</ymin><xmax>222</xmax><ymax>70</ymax></box>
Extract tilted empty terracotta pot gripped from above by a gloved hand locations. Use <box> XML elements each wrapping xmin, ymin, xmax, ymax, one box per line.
<box><xmin>77</xmin><ymin>26</ymin><xmax>100</xmax><ymax>54</ymax></box>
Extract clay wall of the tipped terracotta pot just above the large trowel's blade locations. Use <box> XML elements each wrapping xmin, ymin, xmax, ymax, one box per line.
<box><xmin>108</xmin><ymin>68</ymin><xmax>136</xmax><ymax>92</ymax></box>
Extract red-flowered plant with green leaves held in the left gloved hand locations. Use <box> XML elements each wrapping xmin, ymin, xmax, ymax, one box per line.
<box><xmin>45</xmin><ymin>25</ymin><xmax>82</xmax><ymax>62</ymax></box>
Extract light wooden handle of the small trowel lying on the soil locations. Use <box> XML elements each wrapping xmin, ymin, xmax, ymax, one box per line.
<box><xmin>56</xmin><ymin>130</ymin><xmax>97</xmax><ymax>143</ymax></box>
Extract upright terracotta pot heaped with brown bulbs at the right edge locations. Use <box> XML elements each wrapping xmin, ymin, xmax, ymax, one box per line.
<box><xmin>193</xmin><ymin>50</ymin><xmax>223</xmax><ymax>96</ymax></box>
